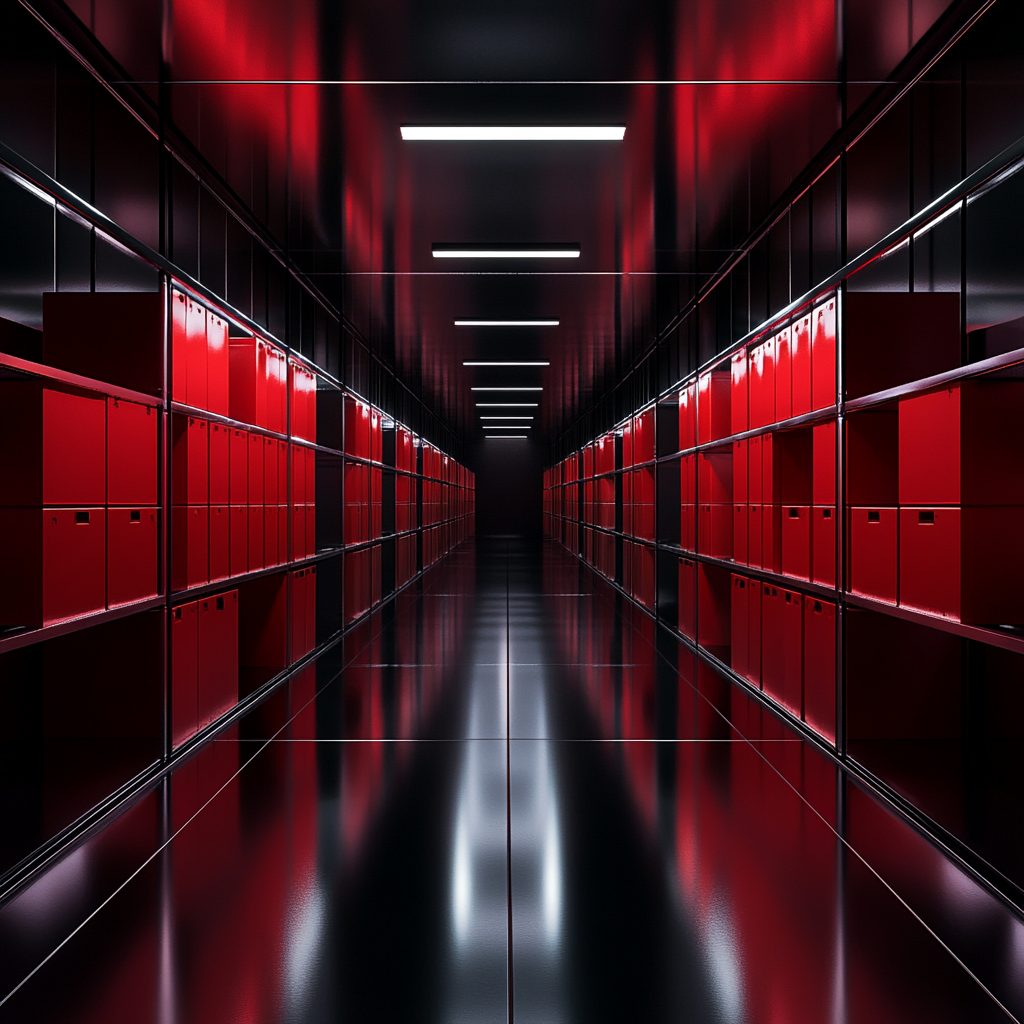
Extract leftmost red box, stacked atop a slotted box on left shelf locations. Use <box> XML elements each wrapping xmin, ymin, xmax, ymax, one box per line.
<box><xmin>0</xmin><ymin>380</ymin><xmax>106</xmax><ymax>509</ymax></box>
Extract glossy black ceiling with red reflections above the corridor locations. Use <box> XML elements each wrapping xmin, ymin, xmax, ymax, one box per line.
<box><xmin>61</xmin><ymin>0</ymin><xmax>945</xmax><ymax>450</ymax></box>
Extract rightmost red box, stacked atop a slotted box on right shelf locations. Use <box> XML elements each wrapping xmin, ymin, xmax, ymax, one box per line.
<box><xmin>899</xmin><ymin>381</ymin><xmax>1024</xmax><ymax>506</ymax></box>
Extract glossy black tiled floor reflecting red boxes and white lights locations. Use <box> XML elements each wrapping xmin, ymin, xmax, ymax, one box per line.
<box><xmin>0</xmin><ymin>541</ymin><xmax>1024</xmax><ymax>1024</ymax></box>
